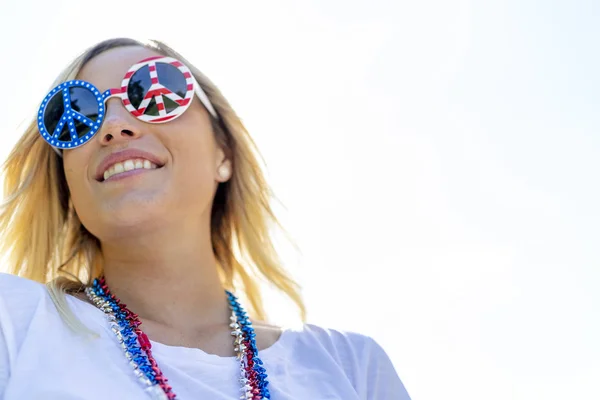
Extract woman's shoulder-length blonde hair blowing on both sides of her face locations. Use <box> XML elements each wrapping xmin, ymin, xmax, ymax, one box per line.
<box><xmin>0</xmin><ymin>39</ymin><xmax>306</xmax><ymax>330</ymax></box>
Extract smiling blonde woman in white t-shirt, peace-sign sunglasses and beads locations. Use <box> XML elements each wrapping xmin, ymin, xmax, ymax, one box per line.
<box><xmin>0</xmin><ymin>39</ymin><xmax>408</xmax><ymax>400</ymax></box>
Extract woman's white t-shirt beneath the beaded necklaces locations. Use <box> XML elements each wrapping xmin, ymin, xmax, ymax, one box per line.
<box><xmin>0</xmin><ymin>273</ymin><xmax>410</xmax><ymax>400</ymax></box>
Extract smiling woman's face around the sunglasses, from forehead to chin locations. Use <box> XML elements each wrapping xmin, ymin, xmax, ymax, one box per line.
<box><xmin>63</xmin><ymin>47</ymin><xmax>226</xmax><ymax>241</ymax></box>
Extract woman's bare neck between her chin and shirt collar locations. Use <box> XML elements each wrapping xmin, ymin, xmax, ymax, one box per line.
<box><xmin>102</xmin><ymin>219</ymin><xmax>229</xmax><ymax>331</ymax></box>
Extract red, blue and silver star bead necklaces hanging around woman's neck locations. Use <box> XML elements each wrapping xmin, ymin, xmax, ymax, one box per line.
<box><xmin>85</xmin><ymin>277</ymin><xmax>271</xmax><ymax>400</ymax></box>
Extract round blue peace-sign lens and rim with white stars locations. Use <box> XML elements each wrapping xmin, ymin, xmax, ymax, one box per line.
<box><xmin>38</xmin><ymin>80</ymin><xmax>110</xmax><ymax>149</ymax></box>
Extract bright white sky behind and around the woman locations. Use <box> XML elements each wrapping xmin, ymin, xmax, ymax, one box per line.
<box><xmin>0</xmin><ymin>0</ymin><xmax>600</xmax><ymax>400</ymax></box>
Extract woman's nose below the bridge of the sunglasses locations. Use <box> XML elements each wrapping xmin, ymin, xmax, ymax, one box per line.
<box><xmin>98</xmin><ymin>101</ymin><xmax>141</xmax><ymax>146</ymax></box>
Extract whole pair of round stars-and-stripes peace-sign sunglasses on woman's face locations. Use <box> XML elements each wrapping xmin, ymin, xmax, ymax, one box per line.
<box><xmin>37</xmin><ymin>56</ymin><xmax>218</xmax><ymax>150</ymax></box>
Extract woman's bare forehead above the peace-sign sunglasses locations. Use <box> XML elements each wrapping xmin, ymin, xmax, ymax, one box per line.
<box><xmin>76</xmin><ymin>46</ymin><xmax>161</xmax><ymax>91</ymax></box>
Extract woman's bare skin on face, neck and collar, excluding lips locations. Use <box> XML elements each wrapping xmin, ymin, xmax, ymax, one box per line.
<box><xmin>63</xmin><ymin>47</ymin><xmax>281</xmax><ymax>356</ymax></box>
